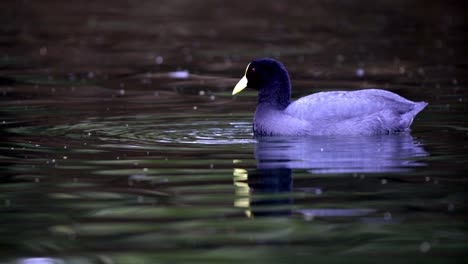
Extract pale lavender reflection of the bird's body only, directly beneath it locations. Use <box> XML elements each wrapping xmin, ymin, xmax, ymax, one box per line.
<box><xmin>255</xmin><ymin>134</ymin><xmax>429</xmax><ymax>173</ymax></box>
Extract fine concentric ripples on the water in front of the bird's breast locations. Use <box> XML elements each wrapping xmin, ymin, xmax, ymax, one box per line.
<box><xmin>45</xmin><ymin>115</ymin><xmax>255</xmax><ymax>146</ymax></box>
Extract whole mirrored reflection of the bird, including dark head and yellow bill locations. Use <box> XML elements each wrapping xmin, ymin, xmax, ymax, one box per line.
<box><xmin>234</xmin><ymin>134</ymin><xmax>428</xmax><ymax>217</ymax></box>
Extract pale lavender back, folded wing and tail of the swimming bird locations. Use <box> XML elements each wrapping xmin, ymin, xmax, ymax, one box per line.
<box><xmin>285</xmin><ymin>89</ymin><xmax>427</xmax><ymax>134</ymax></box>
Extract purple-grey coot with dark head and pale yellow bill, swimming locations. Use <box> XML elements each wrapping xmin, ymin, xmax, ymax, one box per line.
<box><xmin>232</xmin><ymin>58</ymin><xmax>427</xmax><ymax>136</ymax></box>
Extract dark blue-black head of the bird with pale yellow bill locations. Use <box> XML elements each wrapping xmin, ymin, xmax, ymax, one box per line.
<box><xmin>232</xmin><ymin>59</ymin><xmax>291</xmax><ymax>109</ymax></box>
